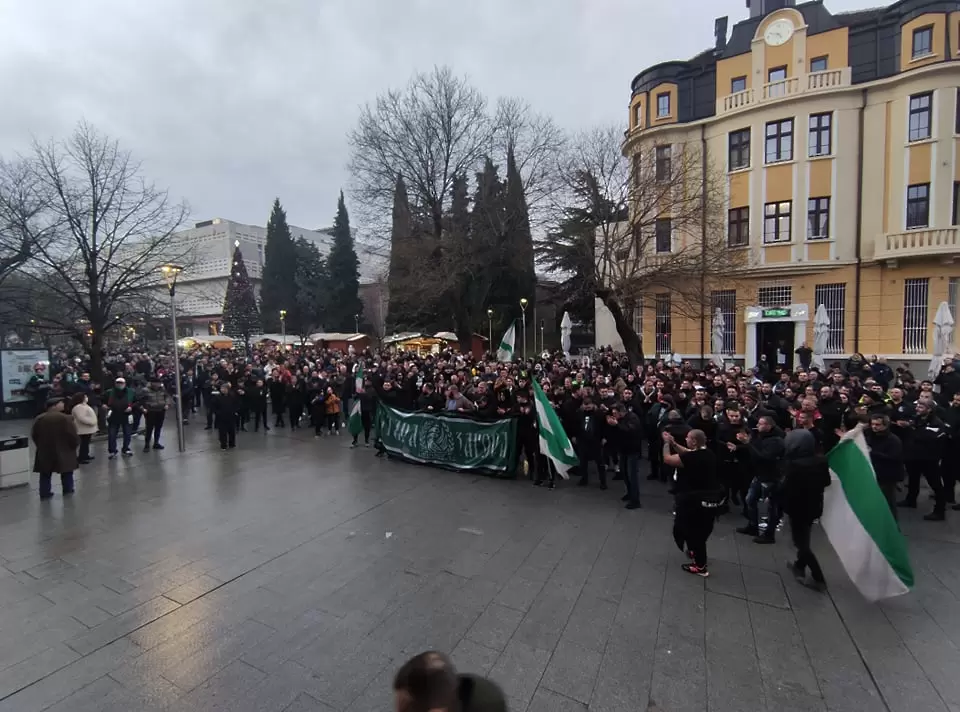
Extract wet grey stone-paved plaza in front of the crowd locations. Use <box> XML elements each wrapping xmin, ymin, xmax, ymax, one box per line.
<box><xmin>0</xmin><ymin>426</ymin><xmax>960</xmax><ymax>712</ymax></box>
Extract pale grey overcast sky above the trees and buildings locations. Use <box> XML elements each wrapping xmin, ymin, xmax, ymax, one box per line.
<box><xmin>0</xmin><ymin>0</ymin><xmax>878</xmax><ymax>227</ymax></box>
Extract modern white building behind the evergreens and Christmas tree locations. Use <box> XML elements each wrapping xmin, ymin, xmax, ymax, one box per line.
<box><xmin>157</xmin><ymin>218</ymin><xmax>384</xmax><ymax>336</ymax></box>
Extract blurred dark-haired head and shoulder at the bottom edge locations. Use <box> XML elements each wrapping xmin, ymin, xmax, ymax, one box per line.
<box><xmin>393</xmin><ymin>650</ymin><xmax>507</xmax><ymax>712</ymax></box>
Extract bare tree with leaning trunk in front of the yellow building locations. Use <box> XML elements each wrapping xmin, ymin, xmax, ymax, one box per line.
<box><xmin>537</xmin><ymin>122</ymin><xmax>747</xmax><ymax>362</ymax></box>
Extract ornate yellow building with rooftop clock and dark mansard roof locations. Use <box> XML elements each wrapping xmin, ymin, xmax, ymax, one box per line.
<box><xmin>596</xmin><ymin>0</ymin><xmax>960</xmax><ymax>366</ymax></box>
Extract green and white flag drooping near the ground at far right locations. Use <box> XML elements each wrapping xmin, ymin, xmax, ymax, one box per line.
<box><xmin>820</xmin><ymin>428</ymin><xmax>913</xmax><ymax>601</ymax></box>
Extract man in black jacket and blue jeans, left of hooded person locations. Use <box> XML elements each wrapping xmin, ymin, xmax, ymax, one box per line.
<box><xmin>737</xmin><ymin>415</ymin><xmax>784</xmax><ymax>544</ymax></box>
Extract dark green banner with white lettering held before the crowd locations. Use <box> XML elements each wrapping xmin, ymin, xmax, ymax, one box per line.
<box><xmin>377</xmin><ymin>403</ymin><xmax>517</xmax><ymax>477</ymax></box>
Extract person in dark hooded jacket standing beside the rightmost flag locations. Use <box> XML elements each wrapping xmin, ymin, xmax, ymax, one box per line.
<box><xmin>780</xmin><ymin>430</ymin><xmax>830</xmax><ymax>590</ymax></box>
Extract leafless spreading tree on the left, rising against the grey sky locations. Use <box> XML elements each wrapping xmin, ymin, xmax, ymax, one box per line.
<box><xmin>8</xmin><ymin>123</ymin><xmax>192</xmax><ymax>374</ymax></box>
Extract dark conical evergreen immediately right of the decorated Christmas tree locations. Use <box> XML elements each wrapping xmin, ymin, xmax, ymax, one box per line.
<box><xmin>260</xmin><ymin>198</ymin><xmax>297</xmax><ymax>333</ymax></box>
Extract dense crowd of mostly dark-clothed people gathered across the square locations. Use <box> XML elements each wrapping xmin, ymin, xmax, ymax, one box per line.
<box><xmin>27</xmin><ymin>347</ymin><xmax>960</xmax><ymax>587</ymax></box>
